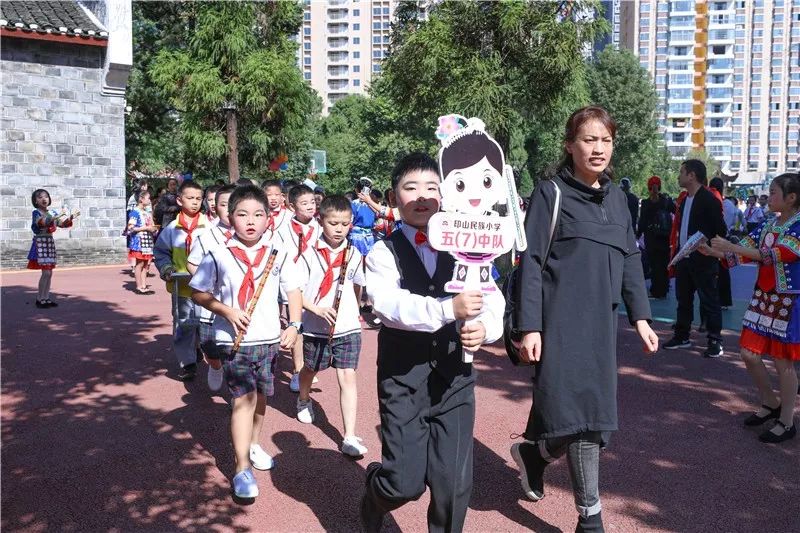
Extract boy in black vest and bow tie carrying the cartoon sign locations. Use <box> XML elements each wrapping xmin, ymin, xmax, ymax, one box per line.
<box><xmin>361</xmin><ymin>154</ymin><xmax>505</xmax><ymax>531</ymax></box>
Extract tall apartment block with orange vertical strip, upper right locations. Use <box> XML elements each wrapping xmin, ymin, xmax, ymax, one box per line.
<box><xmin>619</xmin><ymin>0</ymin><xmax>800</xmax><ymax>184</ymax></box>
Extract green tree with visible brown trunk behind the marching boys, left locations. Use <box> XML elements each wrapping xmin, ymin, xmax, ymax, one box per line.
<box><xmin>149</xmin><ymin>2</ymin><xmax>321</xmax><ymax>181</ymax></box>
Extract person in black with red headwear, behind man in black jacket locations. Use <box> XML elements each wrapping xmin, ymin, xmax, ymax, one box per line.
<box><xmin>636</xmin><ymin>176</ymin><xmax>675</xmax><ymax>298</ymax></box>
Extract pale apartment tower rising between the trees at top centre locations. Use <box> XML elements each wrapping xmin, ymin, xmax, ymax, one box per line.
<box><xmin>298</xmin><ymin>0</ymin><xmax>398</xmax><ymax>114</ymax></box>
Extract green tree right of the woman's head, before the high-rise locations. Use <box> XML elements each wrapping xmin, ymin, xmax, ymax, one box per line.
<box><xmin>588</xmin><ymin>46</ymin><xmax>663</xmax><ymax>190</ymax></box>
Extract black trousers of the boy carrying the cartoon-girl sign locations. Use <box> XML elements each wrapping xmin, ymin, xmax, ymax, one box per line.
<box><xmin>366</xmin><ymin>371</ymin><xmax>475</xmax><ymax>532</ymax></box>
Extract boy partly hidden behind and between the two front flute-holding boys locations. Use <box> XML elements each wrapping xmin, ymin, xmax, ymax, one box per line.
<box><xmin>275</xmin><ymin>185</ymin><xmax>319</xmax><ymax>392</ymax></box>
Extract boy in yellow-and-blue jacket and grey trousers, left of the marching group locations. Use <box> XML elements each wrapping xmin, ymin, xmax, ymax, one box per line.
<box><xmin>153</xmin><ymin>180</ymin><xmax>209</xmax><ymax>380</ymax></box>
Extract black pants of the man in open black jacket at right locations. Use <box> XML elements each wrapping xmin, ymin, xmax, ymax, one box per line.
<box><xmin>675</xmin><ymin>257</ymin><xmax>722</xmax><ymax>341</ymax></box>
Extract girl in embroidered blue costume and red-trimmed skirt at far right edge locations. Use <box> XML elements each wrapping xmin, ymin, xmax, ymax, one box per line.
<box><xmin>700</xmin><ymin>173</ymin><xmax>800</xmax><ymax>443</ymax></box>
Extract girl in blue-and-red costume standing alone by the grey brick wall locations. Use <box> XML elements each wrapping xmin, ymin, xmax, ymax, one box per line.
<box><xmin>28</xmin><ymin>189</ymin><xmax>77</xmax><ymax>309</ymax></box>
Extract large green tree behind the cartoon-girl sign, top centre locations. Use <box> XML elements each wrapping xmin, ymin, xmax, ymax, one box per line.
<box><xmin>371</xmin><ymin>0</ymin><xmax>607</xmax><ymax>189</ymax></box>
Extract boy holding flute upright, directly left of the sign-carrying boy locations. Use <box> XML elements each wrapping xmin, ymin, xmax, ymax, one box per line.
<box><xmin>297</xmin><ymin>196</ymin><xmax>367</xmax><ymax>457</ymax></box>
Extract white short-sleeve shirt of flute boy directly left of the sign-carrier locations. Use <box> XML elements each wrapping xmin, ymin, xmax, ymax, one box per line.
<box><xmin>299</xmin><ymin>238</ymin><xmax>366</xmax><ymax>337</ymax></box>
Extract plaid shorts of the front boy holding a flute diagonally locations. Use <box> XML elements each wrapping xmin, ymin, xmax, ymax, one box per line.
<box><xmin>222</xmin><ymin>342</ymin><xmax>280</xmax><ymax>398</ymax></box>
